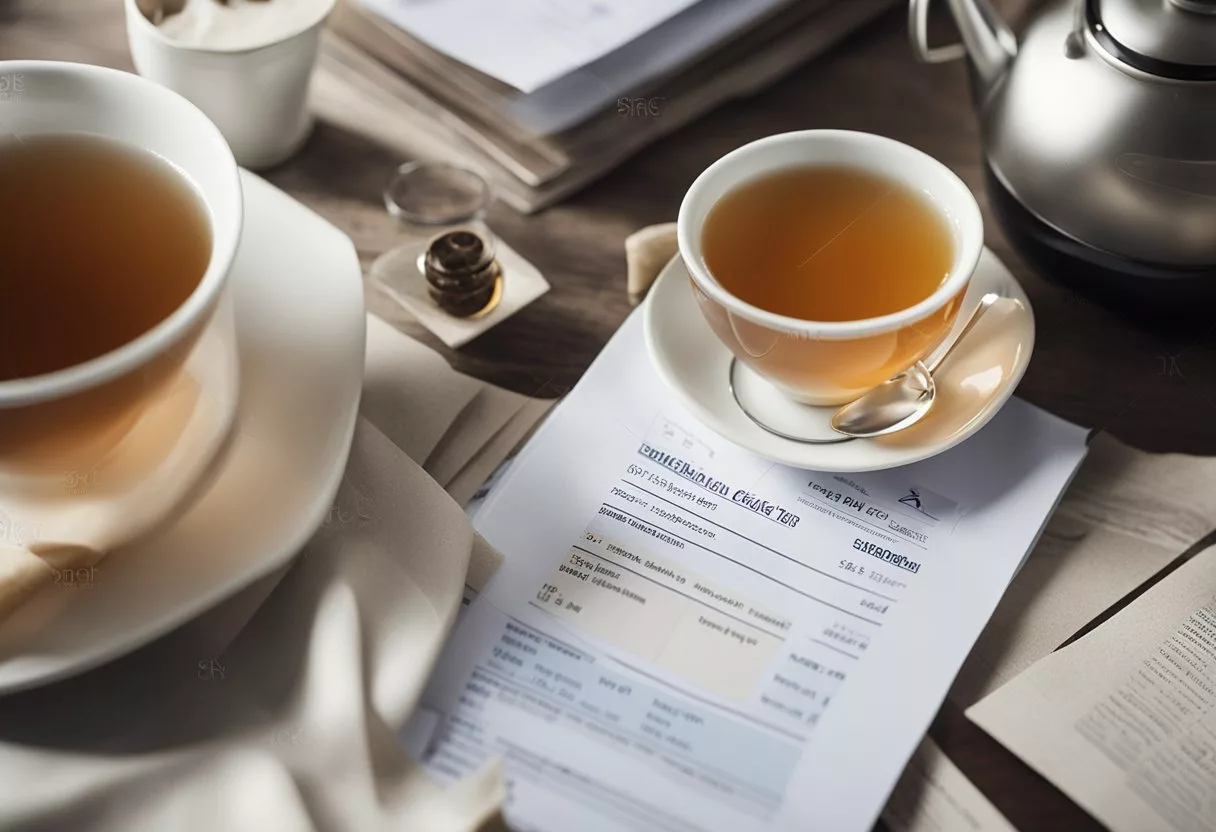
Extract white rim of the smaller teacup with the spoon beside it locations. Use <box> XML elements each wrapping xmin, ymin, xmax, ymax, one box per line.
<box><xmin>676</xmin><ymin>130</ymin><xmax>984</xmax><ymax>341</ymax></box>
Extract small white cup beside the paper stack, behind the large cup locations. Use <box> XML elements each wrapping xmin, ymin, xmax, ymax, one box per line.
<box><xmin>124</xmin><ymin>0</ymin><xmax>336</xmax><ymax>169</ymax></box>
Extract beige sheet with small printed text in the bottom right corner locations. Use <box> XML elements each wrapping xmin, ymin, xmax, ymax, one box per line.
<box><xmin>968</xmin><ymin>549</ymin><xmax>1216</xmax><ymax>832</ymax></box>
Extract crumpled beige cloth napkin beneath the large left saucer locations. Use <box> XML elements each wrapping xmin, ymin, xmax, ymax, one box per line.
<box><xmin>0</xmin><ymin>319</ymin><xmax>548</xmax><ymax>832</ymax></box>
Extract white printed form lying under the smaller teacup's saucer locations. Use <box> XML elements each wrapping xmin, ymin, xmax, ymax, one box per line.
<box><xmin>411</xmin><ymin>314</ymin><xmax>1085</xmax><ymax>832</ymax></box>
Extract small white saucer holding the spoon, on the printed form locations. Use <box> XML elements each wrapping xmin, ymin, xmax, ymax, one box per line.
<box><xmin>643</xmin><ymin>248</ymin><xmax>1035</xmax><ymax>472</ymax></box>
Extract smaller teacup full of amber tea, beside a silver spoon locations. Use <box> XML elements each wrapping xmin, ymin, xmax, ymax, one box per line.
<box><xmin>677</xmin><ymin>130</ymin><xmax>984</xmax><ymax>405</ymax></box>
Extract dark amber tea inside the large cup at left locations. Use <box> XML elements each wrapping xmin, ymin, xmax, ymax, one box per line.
<box><xmin>0</xmin><ymin>135</ymin><xmax>212</xmax><ymax>382</ymax></box>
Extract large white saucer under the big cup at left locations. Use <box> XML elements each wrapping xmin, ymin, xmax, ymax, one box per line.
<box><xmin>0</xmin><ymin>170</ymin><xmax>365</xmax><ymax>693</ymax></box>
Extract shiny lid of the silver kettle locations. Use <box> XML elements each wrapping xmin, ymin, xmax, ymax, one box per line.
<box><xmin>1085</xmin><ymin>0</ymin><xmax>1216</xmax><ymax>80</ymax></box>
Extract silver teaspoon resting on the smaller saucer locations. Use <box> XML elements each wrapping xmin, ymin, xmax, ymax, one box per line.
<box><xmin>832</xmin><ymin>292</ymin><xmax>1001</xmax><ymax>439</ymax></box>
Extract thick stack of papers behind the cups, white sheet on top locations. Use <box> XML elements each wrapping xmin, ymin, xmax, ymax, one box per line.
<box><xmin>313</xmin><ymin>0</ymin><xmax>894</xmax><ymax>210</ymax></box>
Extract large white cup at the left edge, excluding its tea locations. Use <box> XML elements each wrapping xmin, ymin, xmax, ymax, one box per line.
<box><xmin>0</xmin><ymin>61</ymin><xmax>243</xmax><ymax>482</ymax></box>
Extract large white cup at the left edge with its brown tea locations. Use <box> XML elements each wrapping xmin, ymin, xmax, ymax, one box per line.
<box><xmin>0</xmin><ymin>61</ymin><xmax>242</xmax><ymax>476</ymax></box>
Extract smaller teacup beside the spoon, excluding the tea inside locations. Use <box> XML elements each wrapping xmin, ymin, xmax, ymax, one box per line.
<box><xmin>677</xmin><ymin>130</ymin><xmax>984</xmax><ymax>405</ymax></box>
